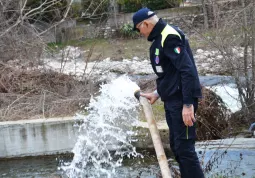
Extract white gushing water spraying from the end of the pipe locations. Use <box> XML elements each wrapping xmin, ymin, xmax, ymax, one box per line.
<box><xmin>61</xmin><ymin>76</ymin><xmax>139</xmax><ymax>178</ymax></box>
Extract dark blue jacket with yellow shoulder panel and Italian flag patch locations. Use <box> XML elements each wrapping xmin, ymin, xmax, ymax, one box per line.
<box><xmin>148</xmin><ymin>19</ymin><xmax>202</xmax><ymax>104</ymax></box>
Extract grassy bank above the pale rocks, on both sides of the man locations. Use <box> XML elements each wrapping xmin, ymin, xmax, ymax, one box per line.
<box><xmin>48</xmin><ymin>25</ymin><xmax>240</xmax><ymax>61</ymax></box>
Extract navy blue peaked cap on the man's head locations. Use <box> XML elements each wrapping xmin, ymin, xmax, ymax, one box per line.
<box><xmin>133</xmin><ymin>7</ymin><xmax>155</xmax><ymax>30</ymax></box>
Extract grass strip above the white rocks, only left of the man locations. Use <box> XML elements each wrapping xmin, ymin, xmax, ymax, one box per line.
<box><xmin>48</xmin><ymin>38</ymin><xmax>151</xmax><ymax>61</ymax></box>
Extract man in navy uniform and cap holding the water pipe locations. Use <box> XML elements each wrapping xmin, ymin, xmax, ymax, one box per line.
<box><xmin>133</xmin><ymin>8</ymin><xmax>204</xmax><ymax>178</ymax></box>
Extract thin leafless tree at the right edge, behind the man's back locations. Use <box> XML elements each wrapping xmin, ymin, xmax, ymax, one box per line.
<box><xmin>201</xmin><ymin>0</ymin><xmax>255</xmax><ymax>122</ymax></box>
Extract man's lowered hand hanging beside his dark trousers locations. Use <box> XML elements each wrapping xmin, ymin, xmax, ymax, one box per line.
<box><xmin>182</xmin><ymin>104</ymin><xmax>196</xmax><ymax>126</ymax></box>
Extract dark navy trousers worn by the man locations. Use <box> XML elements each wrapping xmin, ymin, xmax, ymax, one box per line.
<box><xmin>164</xmin><ymin>97</ymin><xmax>204</xmax><ymax>178</ymax></box>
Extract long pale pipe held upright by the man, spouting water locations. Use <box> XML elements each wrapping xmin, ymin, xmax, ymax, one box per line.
<box><xmin>135</xmin><ymin>92</ymin><xmax>172</xmax><ymax>178</ymax></box>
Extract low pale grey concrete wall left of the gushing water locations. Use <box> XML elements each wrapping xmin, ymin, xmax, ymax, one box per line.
<box><xmin>0</xmin><ymin>118</ymin><xmax>78</xmax><ymax>158</ymax></box>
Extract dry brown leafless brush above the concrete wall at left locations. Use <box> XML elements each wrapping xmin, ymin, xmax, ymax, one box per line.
<box><xmin>0</xmin><ymin>62</ymin><xmax>92</xmax><ymax>121</ymax></box>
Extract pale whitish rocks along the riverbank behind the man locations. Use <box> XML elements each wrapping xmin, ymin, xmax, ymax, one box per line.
<box><xmin>43</xmin><ymin>46</ymin><xmax>251</xmax><ymax>76</ymax></box>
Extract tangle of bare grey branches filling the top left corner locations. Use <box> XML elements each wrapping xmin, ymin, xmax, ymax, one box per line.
<box><xmin>0</xmin><ymin>0</ymin><xmax>73</xmax><ymax>62</ymax></box>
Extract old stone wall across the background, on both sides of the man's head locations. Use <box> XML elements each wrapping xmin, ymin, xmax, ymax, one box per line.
<box><xmin>47</xmin><ymin>0</ymin><xmax>243</xmax><ymax>42</ymax></box>
